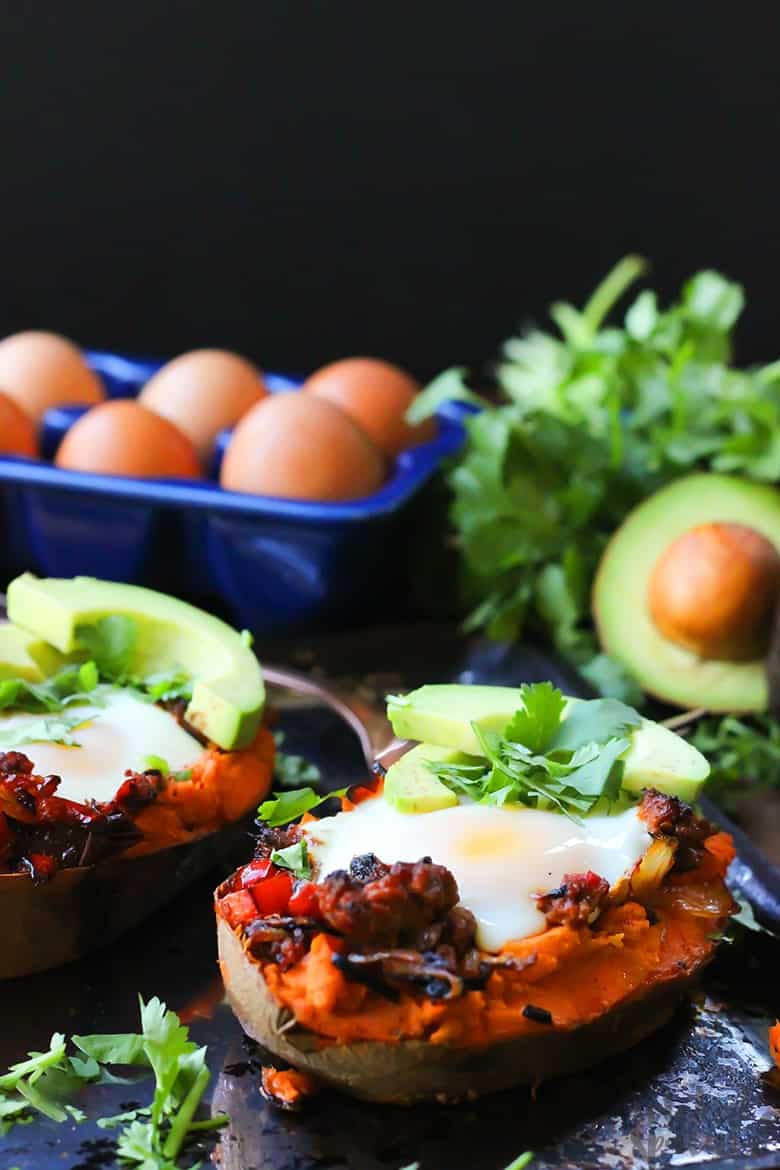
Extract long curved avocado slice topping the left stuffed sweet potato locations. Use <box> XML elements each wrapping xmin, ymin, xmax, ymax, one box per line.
<box><xmin>8</xmin><ymin>573</ymin><xmax>265</xmax><ymax>750</ymax></box>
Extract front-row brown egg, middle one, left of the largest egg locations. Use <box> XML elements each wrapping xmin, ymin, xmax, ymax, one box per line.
<box><xmin>55</xmin><ymin>398</ymin><xmax>202</xmax><ymax>480</ymax></box>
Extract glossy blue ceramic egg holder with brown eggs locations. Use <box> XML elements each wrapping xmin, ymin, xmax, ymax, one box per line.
<box><xmin>0</xmin><ymin>352</ymin><xmax>463</xmax><ymax>635</ymax></box>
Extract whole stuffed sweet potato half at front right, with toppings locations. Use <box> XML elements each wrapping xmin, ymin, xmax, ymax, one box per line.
<box><xmin>215</xmin><ymin>688</ymin><xmax>733</xmax><ymax>1102</ymax></box>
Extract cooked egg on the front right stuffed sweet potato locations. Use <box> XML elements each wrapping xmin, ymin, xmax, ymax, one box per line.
<box><xmin>304</xmin><ymin>798</ymin><xmax>650</xmax><ymax>951</ymax></box>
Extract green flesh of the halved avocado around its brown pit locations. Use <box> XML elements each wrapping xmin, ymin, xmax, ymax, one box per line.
<box><xmin>593</xmin><ymin>474</ymin><xmax>780</xmax><ymax>713</ymax></box>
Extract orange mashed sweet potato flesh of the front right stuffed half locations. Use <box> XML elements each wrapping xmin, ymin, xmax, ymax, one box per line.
<box><xmin>236</xmin><ymin>833</ymin><xmax>733</xmax><ymax>1047</ymax></box>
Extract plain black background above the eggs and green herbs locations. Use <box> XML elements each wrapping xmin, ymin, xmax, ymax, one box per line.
<box><xmin>0</xmin><ymin>0</ymin><xmax>780</xmax><ymax>376</ymax></box>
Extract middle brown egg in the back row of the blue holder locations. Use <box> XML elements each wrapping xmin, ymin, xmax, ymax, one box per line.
<box><xmin>139</xmin><ymin>350</ymin><xmax>268</xmax><ymax>462</ymax></box>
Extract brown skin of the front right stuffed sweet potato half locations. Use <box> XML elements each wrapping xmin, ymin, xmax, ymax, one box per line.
<box><xmin>218</xmin><ymin>917</ymin><xmax>691</xmax><ymax>1104</ymax></box>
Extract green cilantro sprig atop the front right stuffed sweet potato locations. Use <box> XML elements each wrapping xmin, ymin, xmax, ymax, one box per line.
<box><xmin>428</xmin><ymin>682</ymin><xmax>641</xmax><ymax>820</ymax></box>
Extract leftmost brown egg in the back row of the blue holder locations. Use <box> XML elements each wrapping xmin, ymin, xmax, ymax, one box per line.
<box><xmin>0</xmin><ymin>329</ymin><xmax>105</xmax><ymax>422</ymax></box>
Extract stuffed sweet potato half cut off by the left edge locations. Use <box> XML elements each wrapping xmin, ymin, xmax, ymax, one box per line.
<box><xmin>0</xmin><ymin>577</ymin><xmax>274</xmax><ymax>978</ymax></box>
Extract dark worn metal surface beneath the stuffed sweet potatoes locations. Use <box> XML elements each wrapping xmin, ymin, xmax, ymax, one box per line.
<box><xmin>0</xmin><ymin>629</ymin><xmax>780</xmax><ymax>1170</ymax></box>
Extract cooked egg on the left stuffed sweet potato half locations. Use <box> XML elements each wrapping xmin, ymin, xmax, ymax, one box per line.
<box><xmin>0</xmin><ymin>688</ymin><xmax>203</xmax><ymax>800</ymax></box>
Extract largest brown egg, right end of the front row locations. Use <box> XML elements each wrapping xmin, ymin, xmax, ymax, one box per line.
<box><xmin>220</xmin><ymin>391</ymin><xmax>385</xmax><ymax>500</ymax></box>
